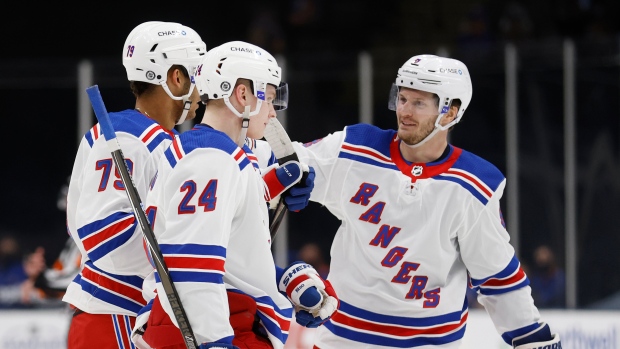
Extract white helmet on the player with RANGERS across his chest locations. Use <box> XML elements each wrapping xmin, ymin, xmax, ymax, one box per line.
<box><xmin>388</xmin><ymin>54</ymin><xmax>472</xmax><ymax>129</ymax></box>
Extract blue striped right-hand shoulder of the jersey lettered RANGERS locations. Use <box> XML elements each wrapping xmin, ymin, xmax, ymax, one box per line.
<box><xmin>436</xmin><ymin>150</ymin><xmax>506</xmax><ymax>205</ymax></box>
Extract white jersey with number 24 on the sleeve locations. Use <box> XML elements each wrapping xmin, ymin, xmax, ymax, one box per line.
<box><xmin>143</xmin><ymin>124</ymin><xmax>292</xmax><ymax>349</ymax></box>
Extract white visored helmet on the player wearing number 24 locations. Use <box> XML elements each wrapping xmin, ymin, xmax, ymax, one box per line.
<box><xmin>196</xmin><ymin>41</ymin><xmax>288</xmax><ymax>117</ymax></box>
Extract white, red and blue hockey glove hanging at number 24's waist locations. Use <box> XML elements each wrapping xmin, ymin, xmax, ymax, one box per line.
<box><xmin>276</xmin><ymin>261</ymin><xmax>340</xmax><ymax>328</ymax></box>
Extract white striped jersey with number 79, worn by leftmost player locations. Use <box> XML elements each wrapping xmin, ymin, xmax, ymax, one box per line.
<box><xmin>63</xmin><ymin>110</ymin><xmax>178</xmax><ymax>316</ymax></box>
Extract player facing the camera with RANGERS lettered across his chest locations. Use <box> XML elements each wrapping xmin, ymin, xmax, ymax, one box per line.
<box><xmin>294</xmin><ymin>55</ymin><xmax>561</xmax><ymax>349</ymax></box>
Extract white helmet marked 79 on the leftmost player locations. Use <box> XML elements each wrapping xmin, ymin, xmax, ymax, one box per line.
<box><xmin>123</xmin><ymin>21</ymin><xmax>207</xmax><ymax>124</ymax></box>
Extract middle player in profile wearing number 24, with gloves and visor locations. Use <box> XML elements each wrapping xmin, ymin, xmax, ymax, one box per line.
<box><xmin>133</xmin><ymin>41</ymin><xmax>337</xmax><ymax>349</ymax></box>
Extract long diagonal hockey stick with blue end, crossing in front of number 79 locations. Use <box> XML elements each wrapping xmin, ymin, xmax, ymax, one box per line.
<box><xmin>86</xmin><ymin>85</ymin><xmax>196</xmax><ymax>349</ymax></box>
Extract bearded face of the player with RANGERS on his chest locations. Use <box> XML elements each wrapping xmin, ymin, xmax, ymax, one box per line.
<box><xmin>396</xmin><ymin>87</ymin><xmax>439</xmax><ymax>145</ymax></box>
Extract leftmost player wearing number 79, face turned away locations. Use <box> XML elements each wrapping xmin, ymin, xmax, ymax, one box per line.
<box><xmin>63</xmin><ymin>22</ymin><xmax>206</xmax><ymax>348</ymax></box>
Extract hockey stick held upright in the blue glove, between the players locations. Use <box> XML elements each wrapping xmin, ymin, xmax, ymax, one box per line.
<box><xmin>264</xmin><ymin>118</ymin><xmax>308</xmax><ymax>241</ymax></box>
